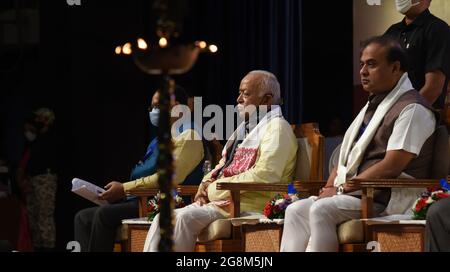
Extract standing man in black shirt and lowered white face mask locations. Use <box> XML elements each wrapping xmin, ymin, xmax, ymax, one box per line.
<box><xmin>384</xmin><ymin>0</ymin><xmax>450</xmax><ymax>110</ymax></box>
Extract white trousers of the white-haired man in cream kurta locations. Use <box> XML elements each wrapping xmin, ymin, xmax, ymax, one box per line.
<box><xmin>144</xmin><ymin>204</ymin><xmax>224</xmax><ymax>252</ymax></box>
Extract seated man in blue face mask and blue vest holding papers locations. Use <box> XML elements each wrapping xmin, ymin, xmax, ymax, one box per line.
<box><xmin>74</xmin><ymin>86</ymin><xmax>204</xmax><ymax>252</ymax></box>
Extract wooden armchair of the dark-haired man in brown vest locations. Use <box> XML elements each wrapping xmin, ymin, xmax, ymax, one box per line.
<box><xmin>295</xmin><ymin>126</ymin><xmax>450</xmax><ymax>252</ymax></box>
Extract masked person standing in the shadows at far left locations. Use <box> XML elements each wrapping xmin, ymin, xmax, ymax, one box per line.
<box><xmin>16</xmin><ymin>108</ymin><xmax>58</xmax><ymax>251</ymax></box>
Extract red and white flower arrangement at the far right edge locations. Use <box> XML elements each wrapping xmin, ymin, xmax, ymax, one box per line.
<box><xmin>412</xmin><ymin>187</ymin><xmax>450</xmax><ymax>220</ymax></box>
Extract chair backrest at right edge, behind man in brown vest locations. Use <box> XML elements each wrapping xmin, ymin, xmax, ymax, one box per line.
<box><xmin>431</xmin><ymin>126</ymin><xmax>450</xmax><ymax>179</ymax></box>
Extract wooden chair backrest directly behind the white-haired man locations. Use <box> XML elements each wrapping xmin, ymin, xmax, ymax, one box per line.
<box><xmin>292</xmin><ymin>123</ymin><xmax>324</xmax><ymax>180</ymax></box>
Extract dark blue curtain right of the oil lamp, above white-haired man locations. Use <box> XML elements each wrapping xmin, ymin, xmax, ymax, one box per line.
<box><xmin>176</xmin><ymin>0</ymin><xmax>303</xmax><ymax>123</ymax></box>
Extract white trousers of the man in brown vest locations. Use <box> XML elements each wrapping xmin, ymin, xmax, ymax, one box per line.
<box><xmin>280</xmin><ymin>195</ymin><xmax>368</xmax><ymax>252</ymax></box>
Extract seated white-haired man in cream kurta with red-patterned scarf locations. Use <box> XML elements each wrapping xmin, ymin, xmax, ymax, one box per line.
<box><xmin>144</xmin><ymin>71</ymin><xmax>297</xmax><ymax>252</ymax></box>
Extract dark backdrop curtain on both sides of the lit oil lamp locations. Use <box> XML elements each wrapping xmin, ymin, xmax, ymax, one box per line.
<box><xmin>0</xmin><ymin>0</ymin><xmax>306</xmax><ymax>250</ymax></box>
